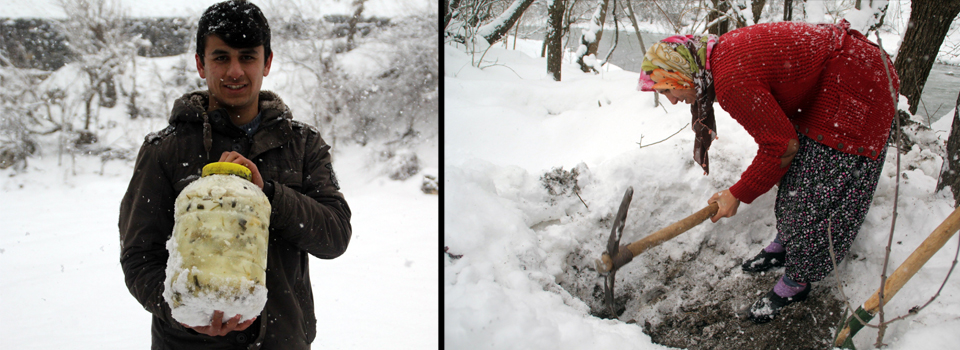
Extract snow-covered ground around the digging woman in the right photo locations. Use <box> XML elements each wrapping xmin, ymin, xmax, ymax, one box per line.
<box><xmin>443</xmin><ymin>34</ymin><xmax>960</xmax><ymax>350</ymax></box>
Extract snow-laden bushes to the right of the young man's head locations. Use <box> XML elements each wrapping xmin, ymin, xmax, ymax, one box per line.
<box><xmin>272</xmin><ymin>2</ymin><xmax>439</xmax><ymax>147</ymax></box>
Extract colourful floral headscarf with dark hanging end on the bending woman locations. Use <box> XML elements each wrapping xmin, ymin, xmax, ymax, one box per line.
<box><xmin>637</xmin><ymin>34</ymin><xmax>717</xmax><ymax>174</ymax></box>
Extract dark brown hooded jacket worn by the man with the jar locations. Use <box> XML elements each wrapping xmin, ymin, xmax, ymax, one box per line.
<box><xmin>120</xmin><ymin>91</ymin><xmax>351</xmax><ymax>349</ymax></box>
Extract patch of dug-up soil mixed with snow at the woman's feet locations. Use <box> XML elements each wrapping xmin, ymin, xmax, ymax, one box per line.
<box><xmin>558</xmin><ymin>241</ymin><xmax>843</xmax><ymax>349</ymax></box>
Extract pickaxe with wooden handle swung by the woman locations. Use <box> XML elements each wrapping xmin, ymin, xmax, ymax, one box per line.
<box><xmin>596</xmin><ymin>187</ymin><xmax>719</xmax><ymax>316</ymax></box>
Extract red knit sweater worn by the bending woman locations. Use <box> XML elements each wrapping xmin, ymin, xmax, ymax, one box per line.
<box><xmin>710</xmin><ymin>22</ymin><xmax>899</xmax><ymax>203</ymax></box>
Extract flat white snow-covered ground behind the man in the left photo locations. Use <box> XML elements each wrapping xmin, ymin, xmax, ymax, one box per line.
<box><xmin>0</xmin><ymin>143</ymin><xmax>439</xmax><ymax>350</ymax></box>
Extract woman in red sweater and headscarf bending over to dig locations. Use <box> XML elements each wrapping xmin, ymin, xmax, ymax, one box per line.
<box><xmin>638</xmin><ymin>20</ymin><xmax>899</xmax><ymax>323</ymax></box>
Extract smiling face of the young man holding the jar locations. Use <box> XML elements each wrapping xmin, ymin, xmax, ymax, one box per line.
<box><xmin>196</xmin><ymin>35</ymin><xmax>273</xmax><ymax>115</ymax></box>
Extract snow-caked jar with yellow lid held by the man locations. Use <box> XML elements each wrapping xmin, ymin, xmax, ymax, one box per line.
<box><xmin>163</xmin><ymin>162</ymin><xmax>270</xmax><ymax>327</ymax></box>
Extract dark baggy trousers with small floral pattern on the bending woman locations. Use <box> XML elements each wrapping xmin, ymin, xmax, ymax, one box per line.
<box><xmin>774</xmin><ymin>135</ymin><xmax>886</xmax><ymax>282</ymax></box>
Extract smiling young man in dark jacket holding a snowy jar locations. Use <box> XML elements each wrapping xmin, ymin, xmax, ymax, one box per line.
<box><xmin>119</xmin><ymin>0</ymin><xmax>351</xmax><ymax>349</ymax></box>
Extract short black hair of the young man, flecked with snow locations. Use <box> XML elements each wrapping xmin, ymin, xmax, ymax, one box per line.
<box><xmin>197</xmin><ymin>0</ymin><xmax>271</xmax><ymax>64</ymax></box>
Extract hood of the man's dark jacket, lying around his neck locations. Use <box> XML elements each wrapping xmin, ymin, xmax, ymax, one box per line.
<box><xmin>169</xmin><ymin>91</ymin><xmax>293</xmax><ymax>124</ymax></box>
